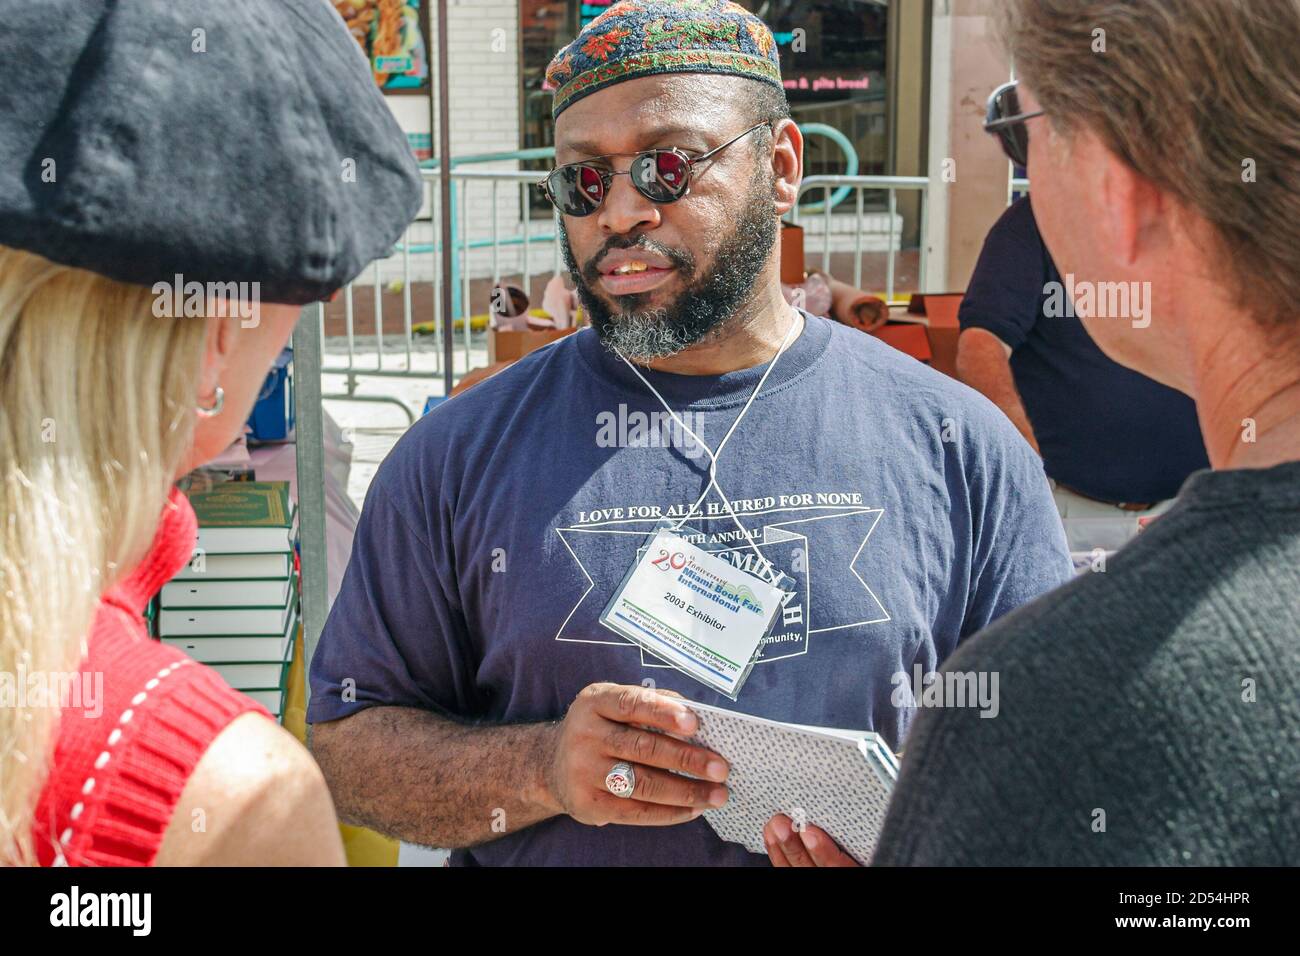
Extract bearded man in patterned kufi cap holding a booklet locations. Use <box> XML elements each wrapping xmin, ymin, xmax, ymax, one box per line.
<box><xmin>308</xmin><ymin>0</ymin><xmax>1070</xmax><ymax>865</ymax></box>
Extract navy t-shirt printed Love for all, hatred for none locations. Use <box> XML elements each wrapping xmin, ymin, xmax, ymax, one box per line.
<box><xmin>308</xmin><ymin>312</ymin><xmax>1071</xmax><ymax>865</ymax></box>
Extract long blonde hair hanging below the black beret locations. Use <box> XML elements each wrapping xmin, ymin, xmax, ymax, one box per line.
<box><xmin>0</xmin><ymin>246</ymin><xmax>205</xmax><ymax>865</ymax></box>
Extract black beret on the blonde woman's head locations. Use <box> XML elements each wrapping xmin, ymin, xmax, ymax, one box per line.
<box><xmin>0</xmin><ymin>0</ymin><xmax>423</xmax><ymax>304</ymax></box>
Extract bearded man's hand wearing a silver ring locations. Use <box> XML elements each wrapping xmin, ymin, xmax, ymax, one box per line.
<box><xmin>546</xmin><ymin>684</ymin><xmax>728</xmax><ymax>826</ymax></box>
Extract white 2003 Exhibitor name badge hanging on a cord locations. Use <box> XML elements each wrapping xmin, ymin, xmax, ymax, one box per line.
<box><xmin>601</xmin><ymin>528</ymin><xmax>785</xmax><ymax>700</ymax></box>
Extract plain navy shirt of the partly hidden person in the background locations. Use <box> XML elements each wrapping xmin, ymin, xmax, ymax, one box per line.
<box><xmin>958</xmin><ymin>199</ymin><xmax>1210</xmax><ymax>502</ymax></box>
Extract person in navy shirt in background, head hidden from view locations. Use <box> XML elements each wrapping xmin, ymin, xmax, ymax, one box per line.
<box><xmin>957</xmin><ymin>199</ymin><xmax>1209</xmax><ymax>551</ymax></box>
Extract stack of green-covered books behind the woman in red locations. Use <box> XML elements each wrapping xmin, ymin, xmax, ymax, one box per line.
<box><xmin>157</xmin><ymin>481</ymin><xmax>298</xmax><ymax>717</ymax></box>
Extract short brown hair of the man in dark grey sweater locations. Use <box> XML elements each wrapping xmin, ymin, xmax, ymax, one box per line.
<box><xmin>1001</xmin><ymin>0</ymin><xmax>1300</xmax><ymax>332</ymax></box>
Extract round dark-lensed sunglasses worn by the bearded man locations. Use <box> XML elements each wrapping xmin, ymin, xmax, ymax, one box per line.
<box><xmin>536</xmin><ymin>122</ymin><xmax>771</xmax><ymax>216</ymax></box>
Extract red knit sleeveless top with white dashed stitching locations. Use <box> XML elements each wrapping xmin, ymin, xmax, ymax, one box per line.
<box><xmin>33</xmin><ymin>488</ymin><xmax>270</xmax><ymax>866</ymax></box>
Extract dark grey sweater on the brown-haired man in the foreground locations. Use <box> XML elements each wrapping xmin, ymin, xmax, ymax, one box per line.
<box><xmin>874</xmin><ymin>462</ymin><xmax>1300</xmax><ymax>866</ymax></box>
